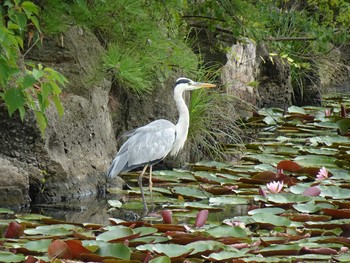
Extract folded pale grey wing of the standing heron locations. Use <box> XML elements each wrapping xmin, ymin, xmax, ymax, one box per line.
<box><xmin>108</xmin><ymin>120</ymin><xmax>176</xmax><ymax>177</ymax></box>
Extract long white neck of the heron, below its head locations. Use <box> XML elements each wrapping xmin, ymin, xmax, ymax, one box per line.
<box><xmin>171</xmin><ymin>89</ymin><xmax>190</xmax><ymax>155</ymax></box>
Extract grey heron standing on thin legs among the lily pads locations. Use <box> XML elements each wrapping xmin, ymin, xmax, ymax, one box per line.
<box><xmin>107</xmin><ymin>78</ymin><xmax>215</xmax><ymax>212</ymax></box>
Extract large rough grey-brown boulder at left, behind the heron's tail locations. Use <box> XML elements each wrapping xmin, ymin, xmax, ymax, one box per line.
<box><xmin>0</xmin><ymin>27</ymin><xmax>116</xmax><ymax>208</ymax></box>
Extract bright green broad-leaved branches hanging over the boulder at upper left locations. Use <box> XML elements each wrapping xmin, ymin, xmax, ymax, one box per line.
<box><xmin>0</xmin><ymin>0</ymin><xmax>66</xmax><ymax>133</ymax></box>
